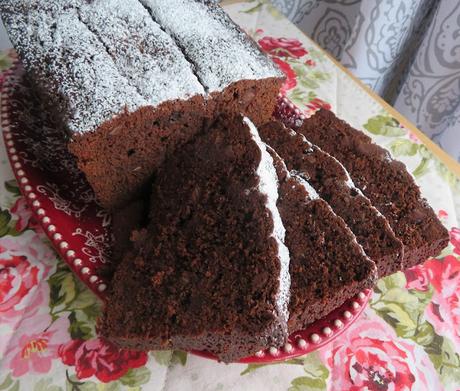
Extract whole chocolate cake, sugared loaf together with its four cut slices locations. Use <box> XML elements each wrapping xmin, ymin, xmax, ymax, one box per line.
<box><xmin>0</xmin><ymin>0</ymin><xmax>449</xmax><ymax>362</ymax></box>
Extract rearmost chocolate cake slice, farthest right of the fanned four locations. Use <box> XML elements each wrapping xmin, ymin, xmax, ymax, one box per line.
<box><xmin>298</xmin><ymin>109</ymin><xmax>449</xmax><ymax>268</ymax></box>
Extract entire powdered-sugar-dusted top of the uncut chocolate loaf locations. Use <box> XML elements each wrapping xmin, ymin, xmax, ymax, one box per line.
<box><xmin>0</xmin><ymin>0</ymin><xmax>282</xmax><ymax>133</ymax></box>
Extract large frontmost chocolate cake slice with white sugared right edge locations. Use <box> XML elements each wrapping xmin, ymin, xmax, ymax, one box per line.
<box><xmin>99</xmin><ymin>118</ymin><xmax>290</xmax><ymax>362</ymax></box>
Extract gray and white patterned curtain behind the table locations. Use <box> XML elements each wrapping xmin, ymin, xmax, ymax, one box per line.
<box><xmin>272</xmin><ymin>0</ymin><xmax>460</xmax><ymax>161</ymax></box>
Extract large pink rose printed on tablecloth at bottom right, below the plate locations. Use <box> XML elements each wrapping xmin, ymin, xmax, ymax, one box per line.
<box><xmin>322</xmin><ymin>318</ymin><xmax>443</xmax><ymax>391</ymax></box>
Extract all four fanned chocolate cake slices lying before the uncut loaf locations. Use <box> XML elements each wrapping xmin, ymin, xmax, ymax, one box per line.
<box><xmin>106</xmin><ymin>111</ymin><xmax>449</xmax><ymax>362</ymax></box>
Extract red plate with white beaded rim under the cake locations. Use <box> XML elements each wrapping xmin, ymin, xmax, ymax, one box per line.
<box><xmin>0</xmin><ymin>62</ymin><xmax>370</xmax><ymax>363</ymax></box>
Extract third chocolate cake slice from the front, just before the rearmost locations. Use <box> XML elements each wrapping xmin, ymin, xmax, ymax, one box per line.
<box><xmin>259</xmin><ymin>122</ymin><xmax>403</xmax><ymax>277</ymax></box>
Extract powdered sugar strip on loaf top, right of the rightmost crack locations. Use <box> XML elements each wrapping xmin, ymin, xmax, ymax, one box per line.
<box><xmin>139</xmin><ymin>0</ymin><xmax>282</xmax><ymax>92</ymax></box>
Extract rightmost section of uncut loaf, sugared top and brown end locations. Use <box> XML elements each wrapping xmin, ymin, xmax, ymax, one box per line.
<box><xmin>139</xmin><ymin>0</ymin><xmax>284</xmax><ymax>125</ymax></box>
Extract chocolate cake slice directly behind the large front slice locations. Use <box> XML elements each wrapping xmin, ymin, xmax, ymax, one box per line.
<box><xmin>268</xmin><ymin>147</ymin><xmax>377</xmax><ymax>333</ymax></box>
